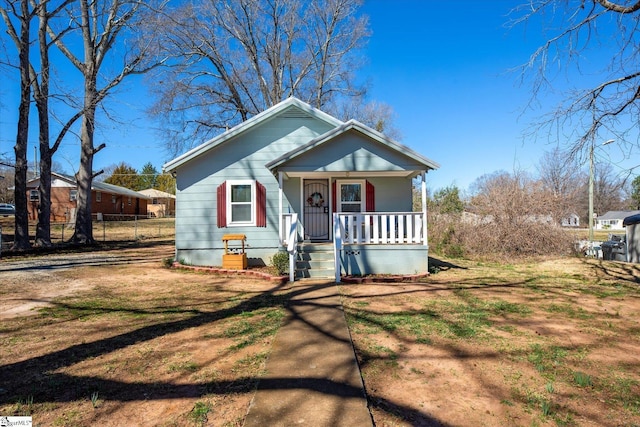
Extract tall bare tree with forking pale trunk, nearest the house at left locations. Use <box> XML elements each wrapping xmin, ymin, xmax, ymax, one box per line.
<box><xmin>48</xmin><ymin>0</ymin><xmax>166</xmax><ymax>244</ymax></box>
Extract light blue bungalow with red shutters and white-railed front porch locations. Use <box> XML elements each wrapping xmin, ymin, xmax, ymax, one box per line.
<box><xmin>163</xmin><ymin>98</ymin><xmax>438</xmax><ymax>282</ymax></box>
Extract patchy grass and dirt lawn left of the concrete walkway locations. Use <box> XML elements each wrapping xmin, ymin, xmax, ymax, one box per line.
<box><xmin>0</xmin><ymin>247</ymin><xmax>285</xmax><ymax>426</ymax></box>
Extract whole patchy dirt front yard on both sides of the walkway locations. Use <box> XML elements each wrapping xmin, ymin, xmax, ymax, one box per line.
<box><xmin>0</xmin><ymin>245</ymin><xmax>640</xmax><ymax>427</ymax></box>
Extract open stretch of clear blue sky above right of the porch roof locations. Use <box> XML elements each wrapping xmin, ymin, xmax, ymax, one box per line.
<box><xmin>365</xmin><ymin>0</ymin><xmax>551</xmax><ymax>190</ymax></box>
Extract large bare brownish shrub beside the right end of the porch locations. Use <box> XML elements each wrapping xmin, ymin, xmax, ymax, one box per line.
<box><xmin>428</xmin><ymin>173</ymin><xmax>575</xmax><ymax>259</ymax></box>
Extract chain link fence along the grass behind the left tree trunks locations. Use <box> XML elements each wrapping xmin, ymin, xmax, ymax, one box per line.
<box><xmin>0</xmin><ymin>215</ymin><xmax>175</xmax><ymax>251</ymax></box>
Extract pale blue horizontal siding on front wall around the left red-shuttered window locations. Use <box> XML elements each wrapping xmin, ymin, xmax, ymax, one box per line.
<box><xmin>176</xmin><ymin>118</ymin><xmax>330</xmax><ymax>265</ymax></box>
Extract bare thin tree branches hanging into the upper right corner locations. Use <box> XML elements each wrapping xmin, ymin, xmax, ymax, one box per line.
<box><xmin>513</xmin><ymin>0</ymin><xmax>640</xmax><ymax>163</ymax></box>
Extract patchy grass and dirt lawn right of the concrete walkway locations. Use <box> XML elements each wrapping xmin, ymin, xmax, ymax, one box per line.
<box><xmin>341</xmin><ymin>258</ymin><xmax>640</xmax><ymax>427</ymax></box>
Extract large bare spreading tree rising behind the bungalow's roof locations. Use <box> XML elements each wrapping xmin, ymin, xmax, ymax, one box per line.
<box><xmin>151</xmin><ymin>0</ymin><xmax>369</xmax><ymax>154</ymax></box>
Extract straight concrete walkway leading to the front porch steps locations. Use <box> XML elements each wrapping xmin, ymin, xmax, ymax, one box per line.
<box><xmin>244</xmin><ymin>281</ymin><xmax>373</xmax><ymax>427</ymax></box>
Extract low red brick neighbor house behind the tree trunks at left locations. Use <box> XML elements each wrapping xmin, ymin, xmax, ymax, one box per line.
<box><xmin>27</xmin><ymin>172</ymin><xmax>150</xmax><ymax>222</ymax></box>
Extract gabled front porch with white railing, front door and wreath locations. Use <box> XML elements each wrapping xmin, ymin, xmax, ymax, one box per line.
<box><xmin>266</xmin><ymin>120</ymin><xmax>438</xmax><ymax>282</ymax></box>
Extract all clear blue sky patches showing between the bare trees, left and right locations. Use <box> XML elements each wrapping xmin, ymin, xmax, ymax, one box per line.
<box><xmin>0</xmin><ymin>0</ymin><xmax>632</xmax><ymax>190</ymax></box>
